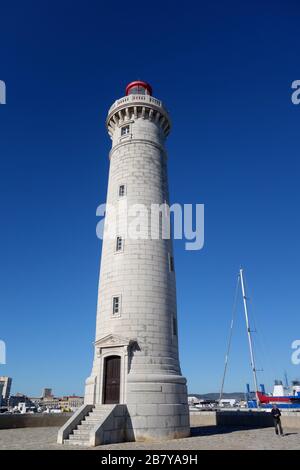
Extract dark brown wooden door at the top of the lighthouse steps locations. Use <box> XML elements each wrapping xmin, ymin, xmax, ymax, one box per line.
<box><xmin>103</xmin><ymin>356</ymin><xmax>121</xmax><ymax>404</ymax></box>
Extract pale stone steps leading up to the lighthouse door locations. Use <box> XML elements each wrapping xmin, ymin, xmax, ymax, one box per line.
<box><xmin>64</xmin><ymin>405</ymin><xmax>116</xmax><ymax>446</ymax></box>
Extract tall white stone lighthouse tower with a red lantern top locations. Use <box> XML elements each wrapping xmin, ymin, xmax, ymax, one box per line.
<box><xmin>81</xmin><ymin>81</ymin><xmax>190</xmax><ymax>440</ymax></box>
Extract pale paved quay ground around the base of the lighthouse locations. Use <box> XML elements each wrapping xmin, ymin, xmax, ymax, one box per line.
<box><xmin>0</xmin><ymin>426</ymin><xmax>300</xmax><ymax>450</ymax></box>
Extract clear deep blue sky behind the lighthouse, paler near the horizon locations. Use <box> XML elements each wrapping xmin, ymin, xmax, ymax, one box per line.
<box><xmin>0</xmin><ymin>0</ymin><xmax>300</xmax><ymax>395</ymax></box>
